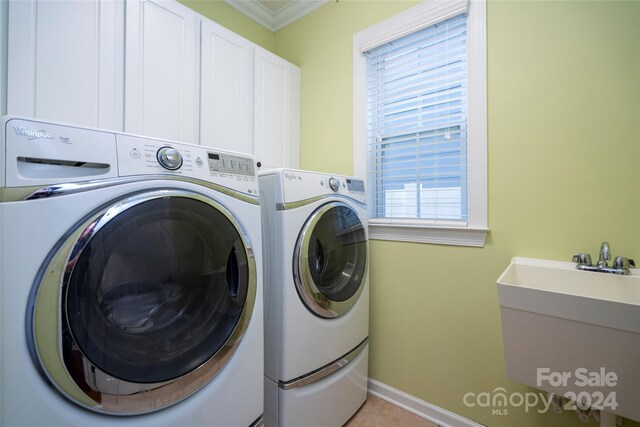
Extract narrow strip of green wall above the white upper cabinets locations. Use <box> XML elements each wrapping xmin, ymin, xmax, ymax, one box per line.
<box><xmin>178</xmin><ymin>0</ymin><xmax>275</xmax><ymax>51</ymax></box>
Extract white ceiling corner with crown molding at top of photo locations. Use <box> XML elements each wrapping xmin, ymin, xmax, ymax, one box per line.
<box><xmin>224</xmin><ymin>0</ymin><xmax>330</xmax><ymax>32</ymax></box>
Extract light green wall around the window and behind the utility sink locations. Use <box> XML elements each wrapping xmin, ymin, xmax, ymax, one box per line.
<box><xmin>275</xmin><ymin>0</ymin><xmax>640</xmax><ymax>427</ymax></box>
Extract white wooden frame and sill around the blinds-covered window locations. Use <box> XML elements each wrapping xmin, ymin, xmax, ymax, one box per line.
<box><xmin>353</xmin><ymin>0</ymin><xmax>489</xmax><ymax>247</ymax></box>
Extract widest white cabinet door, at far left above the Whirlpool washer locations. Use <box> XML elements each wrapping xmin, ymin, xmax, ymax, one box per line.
<box><xmin>7</xmin><ymin>0</ymin><xmax>124</xmax><ymax>130</ymax></box>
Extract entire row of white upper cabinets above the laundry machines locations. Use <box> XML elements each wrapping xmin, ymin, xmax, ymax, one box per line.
<box><xmin>0</xmin><ymin>0</ymin><xmax>300</xmax><ymax>169</ymax></box>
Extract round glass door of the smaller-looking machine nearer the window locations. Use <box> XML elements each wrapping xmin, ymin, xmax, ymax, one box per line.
<box><xmin>294</xmin><ymin>202</ymin><xmax>367</xmax><ymax>318</ymax></box>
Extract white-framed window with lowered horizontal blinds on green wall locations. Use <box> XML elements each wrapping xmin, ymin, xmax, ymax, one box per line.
<box><xmin>354</xmin><ymin>0</ymin><xmax>487</xmax><ymax>246</ymax></box>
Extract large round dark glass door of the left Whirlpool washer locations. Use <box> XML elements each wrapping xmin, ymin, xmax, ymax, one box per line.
<box><xmin>34</xmin><ymin>191</ymin><xmax>255</xmax><ymax>413</ymax></box>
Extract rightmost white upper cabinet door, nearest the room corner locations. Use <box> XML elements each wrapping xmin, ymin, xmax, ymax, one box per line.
<box><xmin>253</xmin><ymin>47</ymin><xmax>300</xmax><ymax>169</ymax></box>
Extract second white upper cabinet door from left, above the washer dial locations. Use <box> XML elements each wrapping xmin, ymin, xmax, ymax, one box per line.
<box><xmin>124</xmin><ymin>0</ymin><xmax>199</xmax><ymax>143</ymax></box>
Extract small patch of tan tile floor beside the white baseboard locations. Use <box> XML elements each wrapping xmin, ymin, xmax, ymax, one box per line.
<box><xmin>345</xmin><ymin>395</ymin><xmax>438</xmax><ymax>427</ymax></box>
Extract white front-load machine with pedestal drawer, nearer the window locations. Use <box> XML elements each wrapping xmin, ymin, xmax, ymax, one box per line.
<box><xmin>259</xmin><ymin>169</ymin><xmax>369</xmax><ymax>427</ymax></box>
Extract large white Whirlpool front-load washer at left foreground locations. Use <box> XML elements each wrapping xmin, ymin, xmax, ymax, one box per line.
<box><xmin>0</xmin><ymin>117</ymin><xmax>263</xmax><ymax>427</ymax></box>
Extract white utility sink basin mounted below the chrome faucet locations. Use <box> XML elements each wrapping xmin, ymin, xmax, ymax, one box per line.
<box><xmin>497</xmin><ymin>257</ymin><xmax>640</xmax><ymax>421</ymax></box>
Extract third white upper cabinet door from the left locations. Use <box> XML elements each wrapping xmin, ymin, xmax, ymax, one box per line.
<box><xmin>200</xmin><ymin>19</ymin><xmax>253</xmax><ymax>154</ymax></box>
